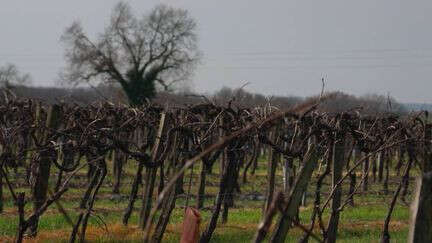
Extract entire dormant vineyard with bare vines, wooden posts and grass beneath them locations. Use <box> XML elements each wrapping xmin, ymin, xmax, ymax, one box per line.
<box><xmin>0</xmin><ymin>96</ymin><xmax>432</xmax><ymax>242</ymax></box>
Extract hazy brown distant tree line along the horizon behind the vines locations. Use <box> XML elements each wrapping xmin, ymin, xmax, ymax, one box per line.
<box><xmin>5</xmin><ymin>86</ymin><xmax>407</xmax><ymax>114</ymax></box>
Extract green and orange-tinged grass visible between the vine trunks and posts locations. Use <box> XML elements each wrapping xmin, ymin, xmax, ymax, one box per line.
<box><xmin>0</xmin><ymin>157</ymin><xmax>414</xmax><ymax>242</ymax></box>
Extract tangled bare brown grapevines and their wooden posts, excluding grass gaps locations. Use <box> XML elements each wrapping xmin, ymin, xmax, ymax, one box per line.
<box><xmin>0</xmin><ymin>96</ymin><xmax>432</xmax><ymax>242</ymax></box>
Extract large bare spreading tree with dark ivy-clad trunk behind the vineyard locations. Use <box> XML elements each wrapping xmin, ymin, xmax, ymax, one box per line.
<box><xmin>61</xmin><ymin>2</ymin><xmax>201</xmax><ymax>106</ymax></box>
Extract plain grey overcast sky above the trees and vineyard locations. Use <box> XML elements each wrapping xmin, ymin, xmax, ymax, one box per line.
<box><xmin>0</xmin><ymin>0</ymin><xmax>432</xmax><ymax>103</ymax></box>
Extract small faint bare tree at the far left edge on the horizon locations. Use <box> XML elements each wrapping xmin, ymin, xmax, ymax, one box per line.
<box><xmin>0</xmin><ymin>63</ymin><xmax>31</xmax><ymax>89</ymax></box>
